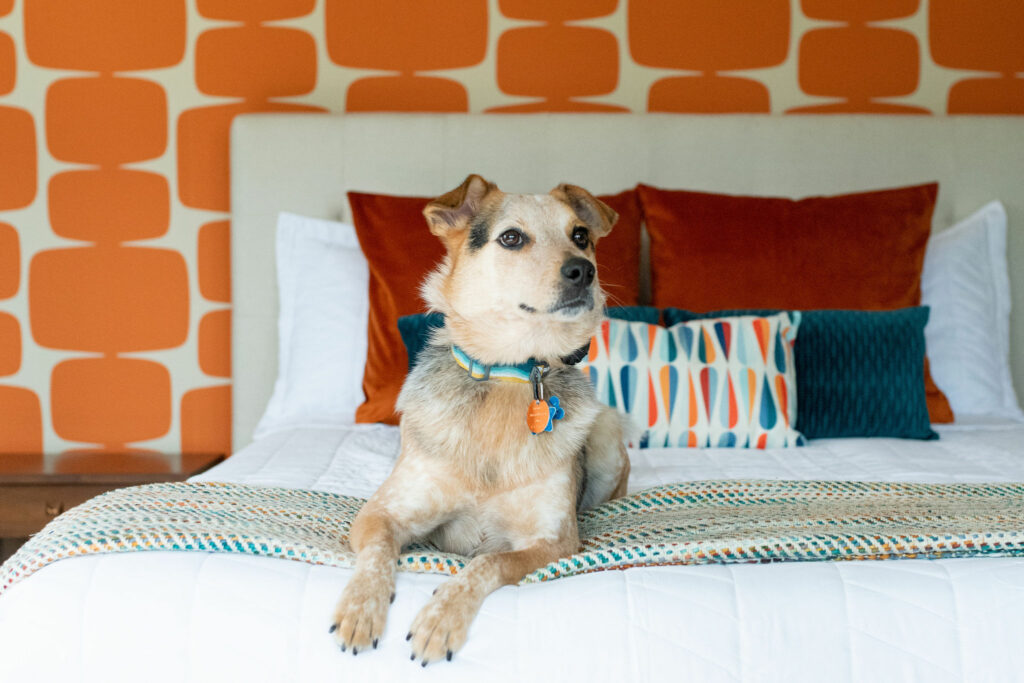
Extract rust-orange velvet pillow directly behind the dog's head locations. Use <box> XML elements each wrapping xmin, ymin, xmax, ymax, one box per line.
<box><xmin>348</xmin><ymin>189</ymin><xmax>640</xmax><ymax>425</ymax></box>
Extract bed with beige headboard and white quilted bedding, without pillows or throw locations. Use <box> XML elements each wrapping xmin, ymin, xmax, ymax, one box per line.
<box><xmin>0</xmin><ymin>115</ymin><xmax>1024</xmax><ymax>681</ymax></box>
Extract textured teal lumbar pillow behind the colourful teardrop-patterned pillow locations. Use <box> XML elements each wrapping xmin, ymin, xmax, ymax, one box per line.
<box><xmin>663</xmin><ymin>306</ymin><xmax>938</xmax><ymax>439</ymax></box>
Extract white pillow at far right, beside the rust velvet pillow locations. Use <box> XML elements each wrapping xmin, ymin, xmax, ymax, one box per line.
<box><xmin>921</xmin><ymin>202</ymin><xmax>1024</xmax><ymax>418</ymax></box>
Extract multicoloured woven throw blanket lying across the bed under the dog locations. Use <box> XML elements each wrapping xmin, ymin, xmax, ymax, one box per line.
<box><xmin>6</xmin><ymin>480</ymin><xmax>1024</xmax><ymax>593</ymax></box>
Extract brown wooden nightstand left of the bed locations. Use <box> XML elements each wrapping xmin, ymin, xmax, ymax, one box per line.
<box><xmin>0</xmin><ymin>453</ymin><xmax>224</xmax><ymax>562</ymax></box>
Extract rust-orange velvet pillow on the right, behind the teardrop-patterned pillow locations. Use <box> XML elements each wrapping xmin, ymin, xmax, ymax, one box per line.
<box><xmin>638</xmin><ymin>183</ymin><xmax>953</xmax><ymax>422</ymax></box>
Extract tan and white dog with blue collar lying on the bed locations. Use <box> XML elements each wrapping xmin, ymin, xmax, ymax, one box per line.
<box><xmin>330</xmin><ymin>174</ymin><xmax>630</xmax><ymax>667</ymax></box>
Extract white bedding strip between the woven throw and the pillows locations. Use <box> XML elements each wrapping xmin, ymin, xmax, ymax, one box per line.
<box><xmin>194</xmin><ymin>420</ymin><xmax>1024</xmax><ymax>497</ymax></box>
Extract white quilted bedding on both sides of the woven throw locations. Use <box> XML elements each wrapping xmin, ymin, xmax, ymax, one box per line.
<box><xmin>6</xmin><ymin>422</ymin><xmax>1024</xmax><ymax>682</ymax></box>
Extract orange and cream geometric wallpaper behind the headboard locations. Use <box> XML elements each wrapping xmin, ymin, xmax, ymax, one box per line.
<box><xmin>0</xmin><ymin>0</ymin><xmax>1024</xmax><ymax>469</ymax></box>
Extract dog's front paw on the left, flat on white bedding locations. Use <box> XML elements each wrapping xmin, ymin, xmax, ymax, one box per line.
<box><xmin>330</xmin><ymin>573</ymin><xmax>394</xmax><ymax>654</ymax></box>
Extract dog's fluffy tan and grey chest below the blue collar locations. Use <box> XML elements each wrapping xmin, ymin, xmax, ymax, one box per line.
<box><xmin>398</xmin><ymin>345</ymin><xmax>599</xmax><ymax>555</ymax></box>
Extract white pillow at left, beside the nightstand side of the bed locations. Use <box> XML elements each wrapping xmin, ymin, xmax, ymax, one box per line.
<box><xmin>253</xmin><ymin>213</ymin><xmax>370</xmax><ymax>438</ymax></box>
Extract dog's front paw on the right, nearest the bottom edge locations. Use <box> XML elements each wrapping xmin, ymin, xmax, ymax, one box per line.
<box><xmin>406</xmin><ymin>580</ymin><xmax>480</xmax><ymax>667</ymax></box>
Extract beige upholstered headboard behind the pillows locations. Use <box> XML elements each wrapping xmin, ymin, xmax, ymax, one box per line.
<box><xmin>231</xmin><ymin>114</ymin><xmax>1024</xmax><ymax>449</ymax></box>
